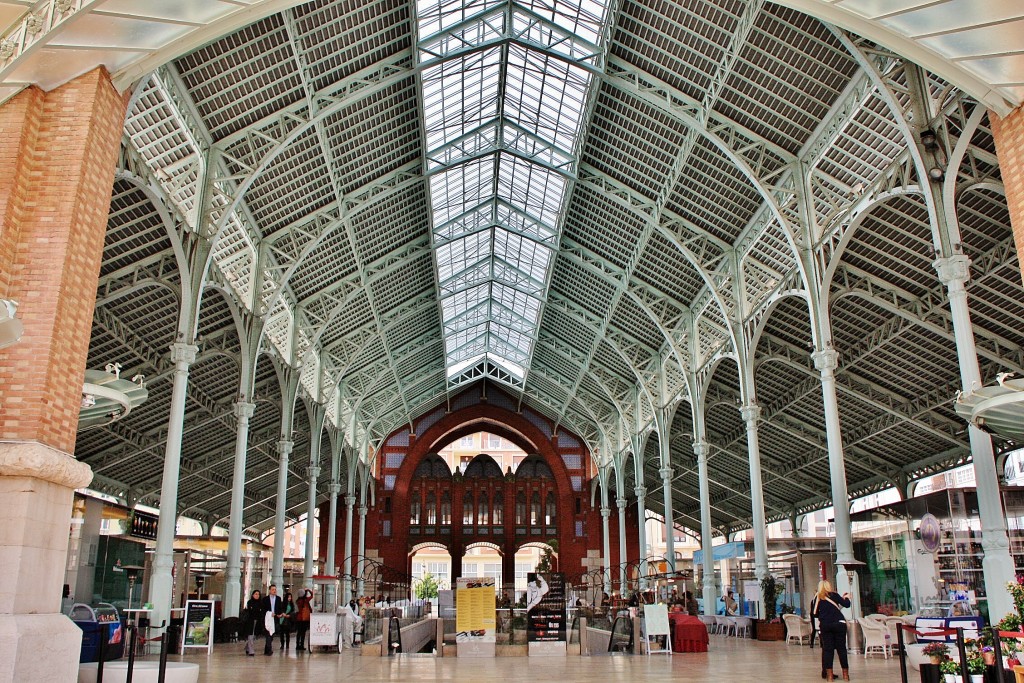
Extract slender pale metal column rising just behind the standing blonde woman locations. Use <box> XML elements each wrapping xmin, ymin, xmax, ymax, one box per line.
<box><xmin>811</xmin><ymin>348</ymin><xmax>860</xmax><ymax>618</ymax></box>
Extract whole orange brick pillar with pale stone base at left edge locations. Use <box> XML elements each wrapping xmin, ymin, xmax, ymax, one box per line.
<box><xmin>0</xmin><ymin>70</ymin><xmax>126</xmax><ymax>681</ymax></box>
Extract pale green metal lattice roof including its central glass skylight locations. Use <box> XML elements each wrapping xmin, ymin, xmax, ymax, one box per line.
<box><xmin>0</xmin><ymin>0</ymin><xmax>1011</xmax><ymax>529</ymax></box>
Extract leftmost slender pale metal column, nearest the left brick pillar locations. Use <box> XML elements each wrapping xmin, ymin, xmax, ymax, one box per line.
<box><xmin>150</xmin><ymin>342</ymin><xmax>199</xmax><ymax>624</ymax></box>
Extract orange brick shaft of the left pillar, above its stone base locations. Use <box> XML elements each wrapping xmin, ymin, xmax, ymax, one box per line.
<box><xmin>0</xmin><ymin>69</ymin><xmax>127</xmax><ymax>453</ymax></box>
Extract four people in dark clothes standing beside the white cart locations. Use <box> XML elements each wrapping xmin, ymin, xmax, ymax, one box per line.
<box><xmin>243</xmin><ymin>586</ymin><xmax>313</xmax><ymax>656</ymax></box>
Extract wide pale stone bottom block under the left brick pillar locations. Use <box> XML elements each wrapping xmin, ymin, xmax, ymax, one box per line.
<box><xmin>0</xmin><ymin>614</ymin><xmax>82</xmax><ymax>683</ymax></box>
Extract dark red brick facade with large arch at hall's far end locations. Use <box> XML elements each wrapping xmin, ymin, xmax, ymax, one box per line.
<box><xmin>319</xmin><ymin>387</ymin><xmax>639</xmax><ymax>583</ymax></box>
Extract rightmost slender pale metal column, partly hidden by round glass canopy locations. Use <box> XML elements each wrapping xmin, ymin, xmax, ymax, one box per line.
<box><xmin>933</xmin><ymin>254</ymin><xmax>1016</xmax><ymax>622</ymax></box>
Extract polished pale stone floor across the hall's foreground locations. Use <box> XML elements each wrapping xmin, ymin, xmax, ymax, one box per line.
<box><xmin>146</xmin><ymin>637</ymin><xmax>916</xmax><ymax>683</ymax></box>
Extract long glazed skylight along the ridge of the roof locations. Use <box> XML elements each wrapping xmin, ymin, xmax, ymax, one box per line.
<box><xmin>417</xmin><ymin>0</ymin><xmax>607</xmax><ymax>382</ymax></box>
